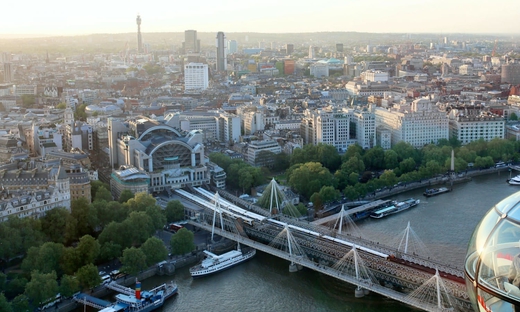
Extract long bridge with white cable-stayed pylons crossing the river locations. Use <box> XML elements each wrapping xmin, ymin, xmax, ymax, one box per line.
<box><xmin>176</xmin><ymin>182</ymin><xmax>471</xmax><ymax>311</ymax></box>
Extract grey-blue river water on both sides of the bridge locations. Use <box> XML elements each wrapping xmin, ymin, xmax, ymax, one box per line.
<box><xmin>110</xmin><ymin>172</ymin><xmax>520</xmax><ymax>312</ymax></box>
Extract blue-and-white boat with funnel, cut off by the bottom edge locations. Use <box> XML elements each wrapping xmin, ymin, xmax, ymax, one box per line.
<box><xmin>99</xmin><ymin>282</ymin><xmax>178</xmax><ymax>312</ymax></box>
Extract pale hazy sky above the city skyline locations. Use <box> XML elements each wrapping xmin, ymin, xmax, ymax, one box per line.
<box><xmin>4</xmin><ymin>0</ymin><xmax>520</xmax><ymax>35</ymax></box>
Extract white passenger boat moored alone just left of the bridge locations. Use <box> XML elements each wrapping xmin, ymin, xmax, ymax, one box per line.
<box><xmin>190</xmin><ymin>244</ymin><xmax>256</xmax><ymax>277</ymax></box>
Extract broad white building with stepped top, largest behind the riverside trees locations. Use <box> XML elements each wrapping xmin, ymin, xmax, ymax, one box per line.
<box><xmin>375</xmin><ymin>98</ymin><xmax>449</xmax><ymax>147</ymax></box>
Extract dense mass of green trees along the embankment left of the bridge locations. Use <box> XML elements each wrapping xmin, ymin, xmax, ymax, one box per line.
<box><xmin>0</xmin><ymin>182</ymin><xmax>194</xmax><ymax>311</ymax></box>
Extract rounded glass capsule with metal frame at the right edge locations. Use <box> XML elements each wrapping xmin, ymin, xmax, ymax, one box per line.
<box><xmin>465</xmin><ymin>192</ymin><xmax>520</xmax><ymax>311</ymax></box>
